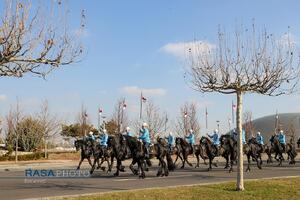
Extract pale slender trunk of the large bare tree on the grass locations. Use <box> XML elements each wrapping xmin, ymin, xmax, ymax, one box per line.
<box><xmin>236</xmin><ymin>91</ymin><xmax>244</xmax><ymax>191</ymax></box>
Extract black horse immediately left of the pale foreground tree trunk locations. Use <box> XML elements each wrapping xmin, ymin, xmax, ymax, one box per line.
<box><xmin>220</xmin><ymin>134</ymin><xmax>237</xmax><ymax>172</ymax></box>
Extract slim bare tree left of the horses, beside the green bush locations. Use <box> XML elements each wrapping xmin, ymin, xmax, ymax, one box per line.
<box><xmin>37</xmin><ymin>100</ymin><xmax>60</xmax><ymax>158</ymax></box>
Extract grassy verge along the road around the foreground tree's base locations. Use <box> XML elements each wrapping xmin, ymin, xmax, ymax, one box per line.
<box><xmin>64</xmin><ymin>178</ymin><xmax>300</xmax><ymax>200</ymax></box>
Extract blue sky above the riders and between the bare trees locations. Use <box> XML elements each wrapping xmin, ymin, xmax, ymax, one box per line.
<box><xmin>0</xmin><ymin>0</ymin><xmax>300</xmax><ymax>134</ymax></box>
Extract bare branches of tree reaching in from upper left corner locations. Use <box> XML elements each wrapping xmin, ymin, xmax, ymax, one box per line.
<box><xmin>0</xmin><ymin>0</ymin><xmax>85</xmax><ymax>77</ymax></box>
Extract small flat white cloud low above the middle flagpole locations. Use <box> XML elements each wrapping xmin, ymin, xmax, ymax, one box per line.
<box><xmin>121</xmin><ymin>86</ymin><xmax>166</xmax><ymax>96</ymax></box>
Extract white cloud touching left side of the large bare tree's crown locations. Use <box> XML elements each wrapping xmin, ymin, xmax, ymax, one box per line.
<box><xmin>160</xmin><ymin>40</ymin><xmax>215</xmax><ymax>58</ymax></box>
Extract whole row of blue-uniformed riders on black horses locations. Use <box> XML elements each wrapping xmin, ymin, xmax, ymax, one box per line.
<box><xmin>75</xmin><ymin>123</ymin><xmax>297</xmax><ymax>178</ymax></box>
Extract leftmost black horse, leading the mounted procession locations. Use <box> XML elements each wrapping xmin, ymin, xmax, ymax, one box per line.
<box><xmin>75</xmin><ymin>138</ymin><xmax>93</xmax><ymax>170</ymax></box>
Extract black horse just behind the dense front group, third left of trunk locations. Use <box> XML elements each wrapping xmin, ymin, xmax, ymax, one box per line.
<box><xmin>174</xmin><ymin>137</ymin><xmax>193</xmax><ymax>169</ymax></box>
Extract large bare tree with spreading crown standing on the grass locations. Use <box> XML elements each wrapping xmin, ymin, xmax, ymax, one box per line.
<box><xmin>186</xmin><ymin>25</ymin><xmax>299</xmax><ymax>191</ymax></box>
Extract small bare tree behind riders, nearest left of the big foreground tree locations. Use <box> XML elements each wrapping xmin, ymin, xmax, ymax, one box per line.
<box><xmin>176</xmin><ymin>102</ymin><xmax>200</xmax><ymax>138</ymax></box>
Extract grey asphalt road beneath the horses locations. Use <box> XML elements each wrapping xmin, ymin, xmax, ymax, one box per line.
<box><xmin>0</xmin><ymin>160</ymin><xmax>300</xmax><ymax>200</ymax></box>
